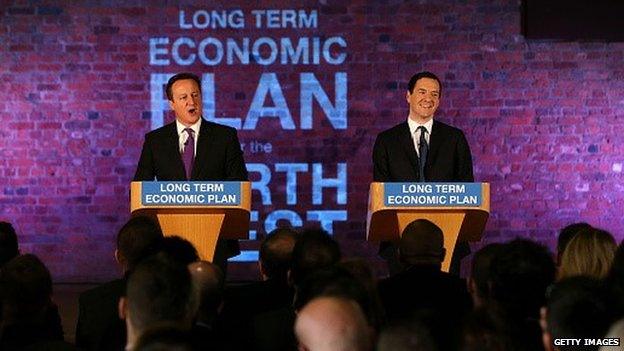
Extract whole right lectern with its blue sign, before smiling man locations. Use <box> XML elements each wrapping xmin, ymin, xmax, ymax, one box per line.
<box><xmin>366</xmin><ymin>183</ymin><xmax>490</xmax><ymax>272</ymax></box>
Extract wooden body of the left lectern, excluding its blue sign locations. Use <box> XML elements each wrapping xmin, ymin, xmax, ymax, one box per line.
<box><xmin>130</xmin><ymin>182</ymin><xmax>251</xmax><ymax>261</ymax></box>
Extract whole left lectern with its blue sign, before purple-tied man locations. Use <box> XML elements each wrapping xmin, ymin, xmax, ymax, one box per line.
<box><xmin>130</xmin><ymin>181</ymin><xmax>251</xmax><ymax>261</ymax></box>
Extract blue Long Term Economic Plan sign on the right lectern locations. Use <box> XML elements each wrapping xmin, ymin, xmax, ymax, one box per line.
<box><xmin>384</xmin><ymin>183</ymin><xmax>483</xmax><ymax>207</ymax></box>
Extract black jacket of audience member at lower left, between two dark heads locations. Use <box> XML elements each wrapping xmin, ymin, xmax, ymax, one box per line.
<box><xmin>76</xmin><ymin>279</ymin><xmax>126</xmax><ymax>350</ymax></box>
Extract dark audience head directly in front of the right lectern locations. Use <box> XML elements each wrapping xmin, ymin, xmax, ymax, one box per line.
<box><xmin>399</xmin><ymin>219</ymin><xmax>446</xmax><ymax>266</ymax></box>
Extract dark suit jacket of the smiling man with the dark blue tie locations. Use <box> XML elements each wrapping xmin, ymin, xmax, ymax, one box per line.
<box><xmin>373</xmin><ymin>119</ymin><xmax>474</xmax><ymax>182</ymax></box>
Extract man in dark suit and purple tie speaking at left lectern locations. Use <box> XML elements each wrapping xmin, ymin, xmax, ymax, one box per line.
<box><xmin>134</xmin><ymin>73</ymin><xmax>247</xmax><ymax>273</ymax></box>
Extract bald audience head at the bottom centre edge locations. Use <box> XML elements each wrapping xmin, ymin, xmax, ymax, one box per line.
<box><xmin>295</xmin><ymin>297</ymin><xmax>373</xmax><ymax>351</ymax></box>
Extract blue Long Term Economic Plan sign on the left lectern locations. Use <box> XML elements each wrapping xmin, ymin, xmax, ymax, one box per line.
<box><xmin>141</xmin><ymin>182</ymin><xmax>241</xmax><ymax>206</ymax></box>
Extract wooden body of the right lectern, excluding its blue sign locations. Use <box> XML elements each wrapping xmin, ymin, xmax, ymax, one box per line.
<box><xmin>366</xmin><ymin>183</ymin><xmax>490</xmax><ymax>272</ymax></box>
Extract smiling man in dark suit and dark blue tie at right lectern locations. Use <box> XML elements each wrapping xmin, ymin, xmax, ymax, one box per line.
<box><xmin>373</xmin><ymin>71</ymin><xmax>474</xmax><ymax>271</ymax></box>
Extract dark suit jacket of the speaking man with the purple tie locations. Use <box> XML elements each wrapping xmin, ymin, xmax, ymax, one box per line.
<box><xmin>134</xmin><ymin>119</ymin><xmax>248</xmax><ymax>260</ymax></box>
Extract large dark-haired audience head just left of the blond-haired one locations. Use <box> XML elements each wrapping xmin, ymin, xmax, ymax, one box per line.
<box><xmin>490</xmin><ymin>239</ymin><xmax>555</xmax><ymax>320</ymax></box>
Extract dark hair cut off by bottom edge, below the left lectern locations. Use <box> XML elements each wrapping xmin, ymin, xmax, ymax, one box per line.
<box><xmin>134</xmin><ymin>324</ymin><xmax>195</xmax><ymax>351</ymax></box>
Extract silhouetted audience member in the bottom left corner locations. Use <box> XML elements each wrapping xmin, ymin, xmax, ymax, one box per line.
<box><xmin>0</xmin><ymin>254</ymin><xmax>74</xmax><ymax>350</ymax></box>
